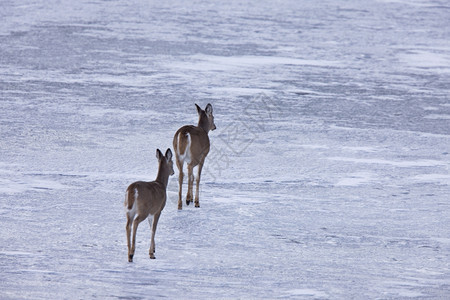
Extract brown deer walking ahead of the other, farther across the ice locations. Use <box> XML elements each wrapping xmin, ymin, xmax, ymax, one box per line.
<box><xmin>173</xmin><ymin>103</ymin><xmax>216</xmax><ymax>210</ymax></box>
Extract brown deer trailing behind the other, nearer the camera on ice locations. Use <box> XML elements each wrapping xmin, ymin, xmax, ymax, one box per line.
<box><xmin>124</xmin><ymin>148</ymin><xmax>175</xmax><ymax>262</ymax></box>
